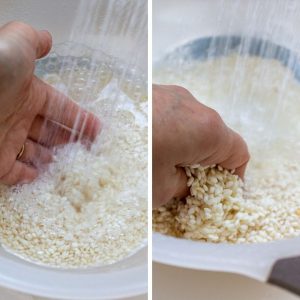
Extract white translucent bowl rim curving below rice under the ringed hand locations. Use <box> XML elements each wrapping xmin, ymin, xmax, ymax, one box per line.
<box><xmin>0</xmin><ymin>247</ymin><xmax>147</xmax><ymax>300</ymax></box>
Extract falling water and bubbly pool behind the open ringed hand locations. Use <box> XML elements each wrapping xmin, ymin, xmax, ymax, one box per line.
<box><xmin>36</xmin><ymin>0</ymin><xmax>147</xmax><ymax>161</ymax></box>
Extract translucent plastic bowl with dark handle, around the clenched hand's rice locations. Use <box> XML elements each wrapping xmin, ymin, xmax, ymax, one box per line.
<box><xmin>153</xmin><ymin>35</ymin><xmax>300</xmax><ymax>288</ymax></box>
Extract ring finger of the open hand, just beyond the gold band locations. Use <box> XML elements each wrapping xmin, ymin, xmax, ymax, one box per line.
<box><xmin>19</xmin><ymin>139</ymin><xmax>52</xmax><ymax>166</ymax></box>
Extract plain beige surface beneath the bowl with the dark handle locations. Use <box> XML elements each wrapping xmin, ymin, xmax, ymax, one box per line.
<box><xmin>152</xmin><ymin>263</ymin><xmax>300</xmax><ymax>300</ymax></box>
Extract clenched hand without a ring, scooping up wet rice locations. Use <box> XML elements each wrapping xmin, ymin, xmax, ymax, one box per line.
<box><xmin>153</xmin><ymin>85</ymin><xmax>250</xmax><ymax>208</ymax></box>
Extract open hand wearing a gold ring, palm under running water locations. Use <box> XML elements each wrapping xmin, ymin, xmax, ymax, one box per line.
<box><xmin>0</xmin><ymin>22</ymin><xmax>101</xmax><ymax>185</ymax></box>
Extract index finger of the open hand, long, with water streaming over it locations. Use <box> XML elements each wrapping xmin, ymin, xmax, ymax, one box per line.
<box><xmin>34</xmin><ymin>77</ymin><xmax>101</xmax><ymax>141</ymax></box>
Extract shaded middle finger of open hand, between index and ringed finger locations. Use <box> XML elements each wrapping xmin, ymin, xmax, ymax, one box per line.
<box><xmin>28</xmin><ymin>116</ymin><xmax>78</xmax><ymax>147</ymax></box>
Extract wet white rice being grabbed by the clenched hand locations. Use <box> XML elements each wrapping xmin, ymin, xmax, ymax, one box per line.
<box><xmin>153</xmin><ymin>56</ymin><xmax>300</xmax><ymax>243</ymax></box>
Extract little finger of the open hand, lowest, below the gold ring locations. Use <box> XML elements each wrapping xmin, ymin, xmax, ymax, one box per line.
<box><xmin>0</xmin><ymin>161</ymin><xmax>38</xmax><ymax>185</ymax></box>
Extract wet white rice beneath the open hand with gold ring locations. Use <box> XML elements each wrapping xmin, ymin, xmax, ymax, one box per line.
<box><xmin>0</xmin><ymin>58</ymin><xmax>147</xmax><ymax>268</ymax></box>
